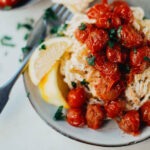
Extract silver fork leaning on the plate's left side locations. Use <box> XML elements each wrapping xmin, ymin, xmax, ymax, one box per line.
<box><xmin>0</xmin><ymin>4</ymin><xmax>72</xmax><ymax>113</ymax></box>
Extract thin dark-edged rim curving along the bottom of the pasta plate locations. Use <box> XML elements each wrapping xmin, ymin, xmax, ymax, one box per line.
<box><xmin>23</xmin><ymin>71</ymin><xmax>150</xmax><ymax>147</ymax></box>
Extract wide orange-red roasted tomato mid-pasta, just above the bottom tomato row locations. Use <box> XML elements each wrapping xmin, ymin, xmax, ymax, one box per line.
<box><xmin>95</xmin><ymin>77</ymin><xmax>124</xmax><ymax>102</ymax></box>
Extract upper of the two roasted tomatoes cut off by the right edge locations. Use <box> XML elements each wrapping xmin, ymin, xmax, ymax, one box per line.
<box><xmin>130</xmin><ymin>46</ymin><xmax>150</xmax><ymax>73</ymax></box>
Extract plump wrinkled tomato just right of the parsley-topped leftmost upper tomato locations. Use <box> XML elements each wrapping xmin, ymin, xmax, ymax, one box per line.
<box><xmin>86</xmin><ymin>29</ymin><xmax>109</xmax><ymax>54</ymax></box>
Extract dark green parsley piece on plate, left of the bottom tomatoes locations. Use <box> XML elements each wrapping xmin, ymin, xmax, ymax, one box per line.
<box><xmin>53</xmin><ymin>106</ymin><xmax>66</xmax><ymax>121</ymax></box>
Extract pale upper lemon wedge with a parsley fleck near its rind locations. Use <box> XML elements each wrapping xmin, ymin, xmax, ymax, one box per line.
<box><xmin>29</xmin><ymin>37</ymin><xmax>72</xmax><ymax>85</ymax></box>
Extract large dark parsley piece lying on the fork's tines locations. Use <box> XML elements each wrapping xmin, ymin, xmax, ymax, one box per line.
<box><xmin>43</xmin><ymin>8</ymin><xmax>58</xmax><ymax>20</ymax></box>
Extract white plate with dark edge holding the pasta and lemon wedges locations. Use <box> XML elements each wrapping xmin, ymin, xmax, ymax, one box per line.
<box><xmin>24</xmin><ymin>0</ymin><xmax>150</xmax><ymax>147</ymax></box>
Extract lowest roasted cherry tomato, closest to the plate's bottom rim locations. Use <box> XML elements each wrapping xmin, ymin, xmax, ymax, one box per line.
<box><xmin>119</xmin><ymin>110</ymin><xmax>140</xmax><ymax>135</ymax></box>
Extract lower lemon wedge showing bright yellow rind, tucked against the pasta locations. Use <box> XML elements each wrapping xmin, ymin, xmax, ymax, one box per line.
<box><xmin>39</xmin><ymin>61</ymin><xmax>68</xmax><ymax>108</ymax></box>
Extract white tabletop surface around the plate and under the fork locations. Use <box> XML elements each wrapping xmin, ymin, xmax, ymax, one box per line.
<box><xmin>0</xmin><ymin>0</ymin><xmax>150</xmax><ymax>150</ymax></box>
